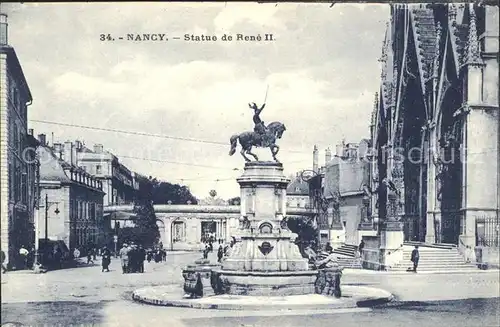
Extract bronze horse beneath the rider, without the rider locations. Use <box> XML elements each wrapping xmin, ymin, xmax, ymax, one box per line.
<box><xmin>229</xmin><ymin>121</ymin><xmax>286</xmax><ymax>162</ymax></box>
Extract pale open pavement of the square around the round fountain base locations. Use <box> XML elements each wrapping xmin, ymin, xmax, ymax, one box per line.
<box><xmin>1</xmin><ymin>253</ymin><xmax>500</xmax><ymax>327</ymax></box>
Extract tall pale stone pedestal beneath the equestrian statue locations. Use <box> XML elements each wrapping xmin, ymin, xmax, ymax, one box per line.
<box><xmin>216</xmin><ymin>162</ymin><xmax>317</xmax><ymax>296</ymax></box>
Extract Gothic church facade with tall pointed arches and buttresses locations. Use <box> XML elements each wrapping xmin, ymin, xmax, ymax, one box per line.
<box><xmin>372</xmin><ymin>3</ymin><xmax>500</xmax><ymax>253</ymax></box>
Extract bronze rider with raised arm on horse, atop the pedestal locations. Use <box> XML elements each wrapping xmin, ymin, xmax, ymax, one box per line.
<box><xmin>229</xmin><ymin>102</ymin><xmax>286</xmax><ymax>162</ymax></box>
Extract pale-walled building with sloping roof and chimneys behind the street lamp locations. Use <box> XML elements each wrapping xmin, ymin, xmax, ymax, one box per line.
<box><xmin>37</xmin><ymin>137</ymin><xmax>104</xmax><ymax>250</ymax></box>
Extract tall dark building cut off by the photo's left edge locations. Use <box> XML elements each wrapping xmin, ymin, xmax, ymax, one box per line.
<box><xmin>0</xmin><ymin>13</ymin><xmax>37</xmax><ymax>267</ymax></box>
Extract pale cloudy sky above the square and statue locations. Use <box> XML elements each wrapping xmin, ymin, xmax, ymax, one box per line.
<box><xmin>1</xmin><ymin>3</ymin><xmax>389</xmax><ymax>198</ymax></box>
